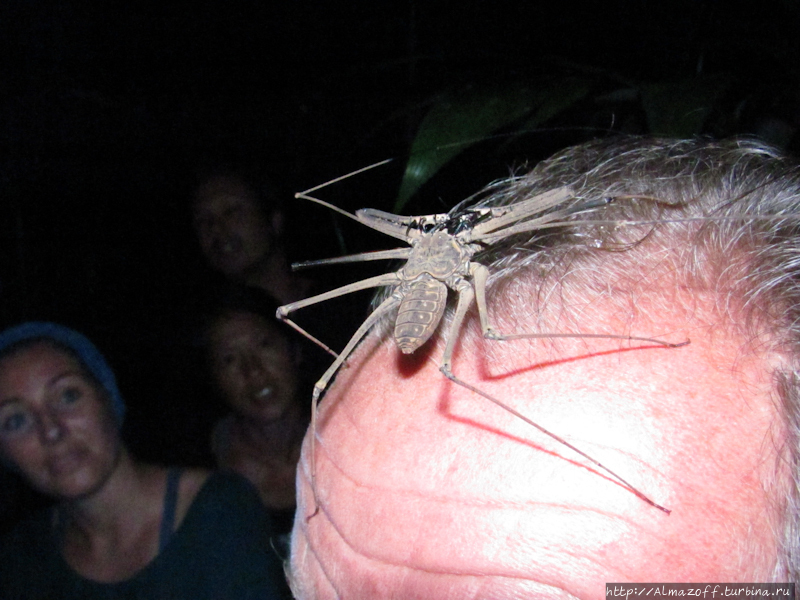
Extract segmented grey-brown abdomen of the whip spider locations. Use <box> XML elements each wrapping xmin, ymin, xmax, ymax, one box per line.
<box><xmin>394</xmin><ymin>273</ymin><xmax>447</xmax><ymax>354</ymax></box>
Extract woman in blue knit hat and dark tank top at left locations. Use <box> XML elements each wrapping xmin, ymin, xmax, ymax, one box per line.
<box><xmin>0</xmin><ymin>322</ymin><xmax>286</xmax><ymax>600</ymax></box>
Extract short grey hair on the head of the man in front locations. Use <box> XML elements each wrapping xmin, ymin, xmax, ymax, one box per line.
<box><xmin>468</xmin><ymin>138</ymin><xmax>800</xmax><ymax>581</ymax></box>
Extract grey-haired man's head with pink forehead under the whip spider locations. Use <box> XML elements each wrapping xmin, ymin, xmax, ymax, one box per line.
<box><xmin>292</xmin><ymin>140</ymin><xmax>800</xmax><ymax>599</ymax></box>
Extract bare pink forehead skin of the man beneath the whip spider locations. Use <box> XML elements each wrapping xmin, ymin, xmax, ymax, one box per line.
<box><xmin>292</xmin><ymin>294</ymin><xmax>786</xmax><ymax>600</ymax></box>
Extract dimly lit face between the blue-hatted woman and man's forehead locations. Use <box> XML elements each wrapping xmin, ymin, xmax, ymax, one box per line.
<box><xmin>210</xmin><ymin>312</ymin><xmax>297</xmax><ymax>422</ymax></box>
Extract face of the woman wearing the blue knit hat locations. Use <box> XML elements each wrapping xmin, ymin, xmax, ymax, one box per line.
<box><xmin>0</xmin><ymin>342</ymin><xmax>122</xmax><ymax>499</ymax></box>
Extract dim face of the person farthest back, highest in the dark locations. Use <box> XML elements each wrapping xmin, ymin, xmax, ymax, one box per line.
<box><xmin>193</xmin><ymin>176</ymin><xmax>277</xmax><ymax>280</ymax></box>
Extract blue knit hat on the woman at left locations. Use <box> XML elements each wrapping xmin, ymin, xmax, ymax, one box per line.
<box><xmin>0</xmin><ymin>321</ymin><xmax>125</xmax><ymax>425</ymax></box>
